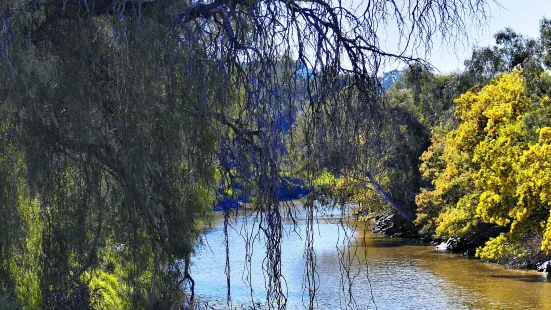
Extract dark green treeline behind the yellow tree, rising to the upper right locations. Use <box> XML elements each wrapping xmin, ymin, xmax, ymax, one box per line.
<box><xmin>306</xmin><ymin>22</ymin><xmax>544</xmax><ymax>232</ymax></box>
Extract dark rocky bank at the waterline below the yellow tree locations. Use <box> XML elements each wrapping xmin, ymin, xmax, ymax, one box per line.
<box><xmin>368</xmin><ymin>212</ymin><xmax>551</xmax><ymax>276</ymax></box>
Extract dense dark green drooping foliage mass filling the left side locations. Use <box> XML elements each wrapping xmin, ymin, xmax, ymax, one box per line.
<box><xmin>0</xmin><ymin>3</ymin><xmax>220</xmax><ymax>309</ymax></box>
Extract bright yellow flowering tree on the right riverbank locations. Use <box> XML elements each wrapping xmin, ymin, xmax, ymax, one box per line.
<box><xmin>416</xmin><ymin>70</ymin><xmax>551</xmax><ymax>260</ymax></box>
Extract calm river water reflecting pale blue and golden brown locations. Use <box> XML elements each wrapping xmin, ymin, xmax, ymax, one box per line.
<box><xmin>191</xmin><ymin>207</ymin><xmax>551</xmax><ymax>309</ymax></box>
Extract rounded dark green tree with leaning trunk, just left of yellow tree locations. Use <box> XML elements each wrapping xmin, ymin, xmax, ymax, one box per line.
<box><xmin>297</xmin><ymin>77</ymin><xmax>429</xmax><ymax>222</ymax></box>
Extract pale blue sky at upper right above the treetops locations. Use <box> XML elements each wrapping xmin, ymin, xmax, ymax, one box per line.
<box><xmin>380</xmin><ymin>0</ymin><xmax>551</xmax><ymax>73</ymax></box>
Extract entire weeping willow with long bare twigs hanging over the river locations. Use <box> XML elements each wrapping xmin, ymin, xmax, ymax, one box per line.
<box><xmin>0</xmin><ymin>0</ymin><xmax>487</xmax><ymax>309</ymax></box>
